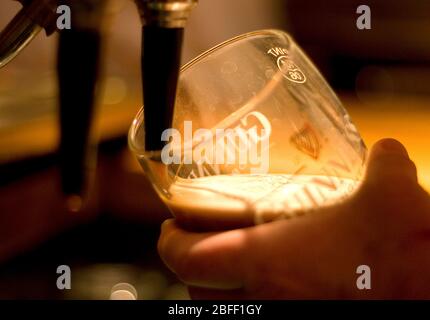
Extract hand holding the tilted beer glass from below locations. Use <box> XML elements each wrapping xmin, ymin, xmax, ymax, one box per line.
<box><xmin>158</xmin><ymin>139</ymin><xmax>430</xmax><ymax>299</ymax></box>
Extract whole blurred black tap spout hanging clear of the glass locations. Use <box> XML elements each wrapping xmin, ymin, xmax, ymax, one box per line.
<box><xmin>57</xmin><ymin>0</ymin><xmax>110</xmax><ymax>211</ymax></box>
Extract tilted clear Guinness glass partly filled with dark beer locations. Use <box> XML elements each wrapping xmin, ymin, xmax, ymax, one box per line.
<box><xmin>129</xmin><ymin>30</ymin><xmax>366</xmax><ymax>230</ymax></box>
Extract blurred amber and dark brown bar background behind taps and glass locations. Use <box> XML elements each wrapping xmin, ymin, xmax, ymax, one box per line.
<box><xmin>0</xmin><ymin>0</ymin><xmax>430</xmax><ymax>299</ymax></box>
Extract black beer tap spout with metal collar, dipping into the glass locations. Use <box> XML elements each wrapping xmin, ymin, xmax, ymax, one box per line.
<box><xmin>135</xmin><ymin>0</ymin><xmax>197</xmax><ymax>152</ymax></box>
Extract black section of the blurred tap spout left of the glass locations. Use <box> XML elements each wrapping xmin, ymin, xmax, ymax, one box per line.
<box><xmin>57</xmin><ymin>28</ymin><xmax>101</xmax><ymax>204</ymax></box>
